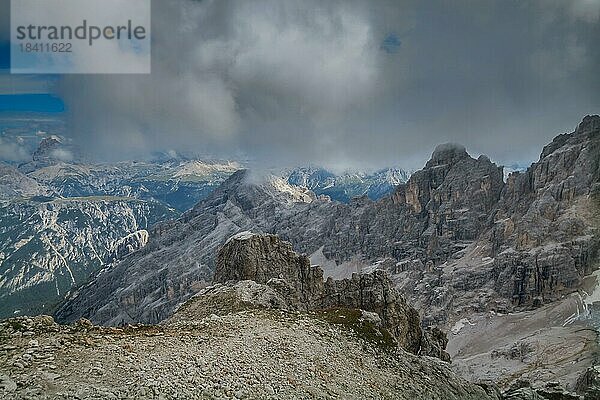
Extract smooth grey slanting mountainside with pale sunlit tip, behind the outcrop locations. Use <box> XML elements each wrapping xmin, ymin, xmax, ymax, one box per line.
<box><xmin>57</xmin><ymin>175</ymin><xmax>315</xmax><ymax>325</ymax></box>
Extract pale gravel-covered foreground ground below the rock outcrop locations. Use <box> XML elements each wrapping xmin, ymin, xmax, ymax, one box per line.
<box><xmin>0</xmin><ymin>310</ymin><xmax>495</xmax><ymax>400</ymax></box>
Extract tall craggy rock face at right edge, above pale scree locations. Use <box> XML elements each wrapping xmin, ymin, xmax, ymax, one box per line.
<box><xmin>488</xmin><ymin>116</ymin><xmax>600</xmax><ymax>306</ymax></box>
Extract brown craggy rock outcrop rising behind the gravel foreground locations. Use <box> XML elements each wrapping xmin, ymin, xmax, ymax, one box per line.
<box><xmin>188</xmin><ymin>232</ymin><xmax>449</xmax><ymax>361</ymax></box>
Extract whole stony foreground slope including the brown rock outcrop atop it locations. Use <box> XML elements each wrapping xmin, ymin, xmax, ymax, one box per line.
<box><xmin>0</xmin><ymin>232</ymin><xmax>500</xmax><ymax>400</ymax></box>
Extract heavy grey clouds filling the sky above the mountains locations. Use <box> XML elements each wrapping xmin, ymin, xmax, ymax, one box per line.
<box><xmin>0</xmin><ymin>0</ymin><xmax>600</xmax><ymax>169</ymax></box>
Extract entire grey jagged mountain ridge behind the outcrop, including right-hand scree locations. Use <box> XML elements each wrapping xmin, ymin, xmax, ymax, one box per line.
<box><xmin>56</xmin><ymin>116</ymin><xmax>600</xmax><ymax>385</ymax></box>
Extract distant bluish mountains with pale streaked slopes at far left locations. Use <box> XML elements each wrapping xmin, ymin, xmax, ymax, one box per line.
<box><xmin>0</xmin><ymin>139</ymin><xmax>244</xmax><ymax>317</ymax></box>
